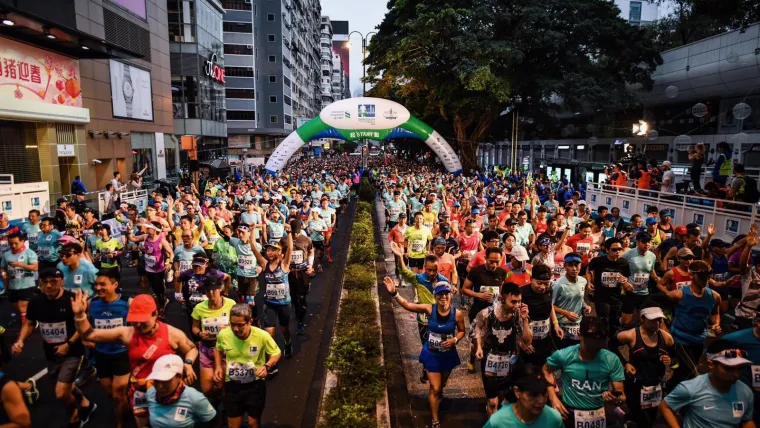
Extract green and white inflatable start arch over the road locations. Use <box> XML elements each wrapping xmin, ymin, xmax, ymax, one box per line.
<box><xmin>266</xmin><ymin>98</ymin><xmax>462</xmax><ymax>175</ymax></box>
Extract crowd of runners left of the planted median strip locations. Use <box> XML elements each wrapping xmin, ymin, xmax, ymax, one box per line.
<box><xmin>0</xmin><ymin>156</ymin><xmax>377</xmax><ymax>428</ymax></box>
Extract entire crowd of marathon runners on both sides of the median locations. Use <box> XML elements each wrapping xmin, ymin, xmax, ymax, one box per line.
<box><xmin>0</xmin><ymin>151</ymin><xmax>760</xmax><ymax>428</ymax></box>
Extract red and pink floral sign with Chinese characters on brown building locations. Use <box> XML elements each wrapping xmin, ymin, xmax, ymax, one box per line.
<box><xmin>0</xmin><ymin>37</ymin><xmax>82</xmax><ymax>107</ymax></box>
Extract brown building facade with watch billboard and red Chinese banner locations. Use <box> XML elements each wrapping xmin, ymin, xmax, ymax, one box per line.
<box><xmin>0</xmin><ymin>0</ymin><xmax>176</xmax><ymax>198</ymax></box>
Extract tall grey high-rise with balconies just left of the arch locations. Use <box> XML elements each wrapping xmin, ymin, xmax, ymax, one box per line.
<box><xmin>222</xmin><ymin>0</ymin><xmax>321</xmax><ymax>164</ymax></box>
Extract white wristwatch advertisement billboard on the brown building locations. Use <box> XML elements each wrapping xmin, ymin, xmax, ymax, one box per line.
<box><xmin>109</xmin><ymin>60</ymin><xmax>153</xmax><ymax>122</ymax></box>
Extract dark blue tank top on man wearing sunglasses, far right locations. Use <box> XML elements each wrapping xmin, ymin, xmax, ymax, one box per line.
<box><xmin>671</xmin><ymin>287</ymin><xmax>715</xmax><ymax>345</ymax></box>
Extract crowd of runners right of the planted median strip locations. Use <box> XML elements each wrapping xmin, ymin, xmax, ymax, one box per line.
<box><xmin>378</xmin><ymin>166</ymin><xmax>760</xmax><ymax>428</ymax></box>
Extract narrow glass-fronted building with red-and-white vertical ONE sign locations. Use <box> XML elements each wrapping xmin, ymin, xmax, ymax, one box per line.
<box><xmin>167</xmin><ymin>0</ymin><xmax>227</xmax><ymax>164</ymax></box>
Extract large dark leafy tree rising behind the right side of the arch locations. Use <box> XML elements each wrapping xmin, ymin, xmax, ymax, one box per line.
<box><xmin>367</xmin><ymin>0</ymin><xmax>661</xmax><ymax>171</ymax></box>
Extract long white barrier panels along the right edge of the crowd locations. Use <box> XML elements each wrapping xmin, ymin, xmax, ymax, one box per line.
<box><xmin>586</xmin><ymin>183</ymin><xmax>758</xmax><ymax>242</ymax></box>
